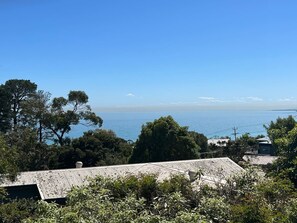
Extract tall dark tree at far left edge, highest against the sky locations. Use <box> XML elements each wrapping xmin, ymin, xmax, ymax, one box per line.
<box><xmin>0</xmin><ymin>79</ymin><xmax>37</xmax><ymax>129</ymax></box>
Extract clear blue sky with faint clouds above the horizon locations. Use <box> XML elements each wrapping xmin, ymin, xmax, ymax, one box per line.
<box><xmin>0</xmin><ymin>0</ymin><xmax>297</xmax><ymax>110</ymax></box>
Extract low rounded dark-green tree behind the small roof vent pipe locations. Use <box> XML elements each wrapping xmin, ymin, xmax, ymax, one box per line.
<box><xmin>52</xmin><ymin>129</ymin><xmax>132</xmax><ymax>168</ymax></box>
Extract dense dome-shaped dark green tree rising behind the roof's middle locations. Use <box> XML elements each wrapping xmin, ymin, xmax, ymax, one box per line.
<box><xmin>130</xmin><ymin>116</ymin><xmax>200</xmax><ymax>163</ymax></box>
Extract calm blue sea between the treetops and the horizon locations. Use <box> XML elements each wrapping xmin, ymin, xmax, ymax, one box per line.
<box><xmin>69</xmin><ymin>110</ymin><xmax>297</xmax><ymax>141</ymax></box>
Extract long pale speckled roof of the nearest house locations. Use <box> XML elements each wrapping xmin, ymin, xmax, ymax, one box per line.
<box><xmin>0</xmin><ymin>158</ymin><xmax>243</xmax><ymax>200</ymax></box>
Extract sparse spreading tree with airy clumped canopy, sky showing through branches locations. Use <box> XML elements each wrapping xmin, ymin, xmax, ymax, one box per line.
<box><xmin>42</xmin><ymin>91</ymin><xmax>103</xmax><ymax>145</ymax></box>
